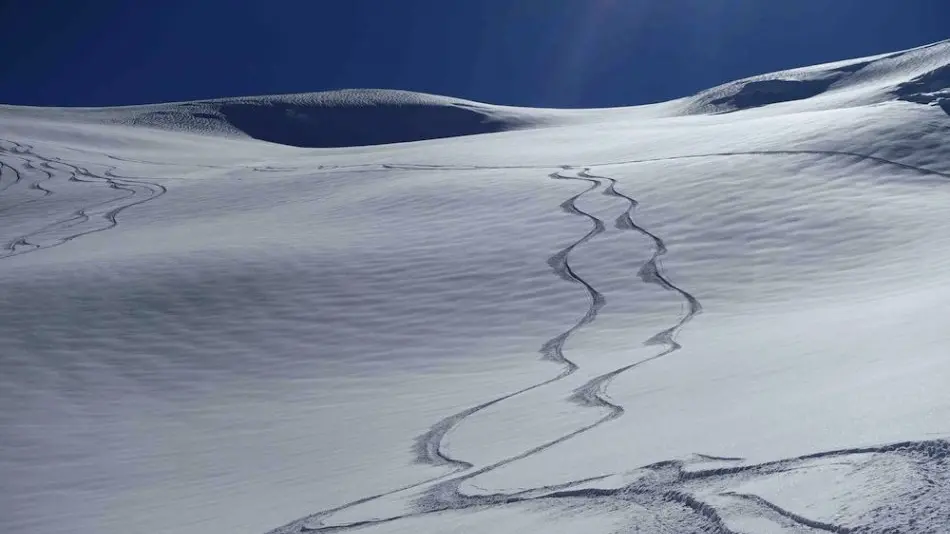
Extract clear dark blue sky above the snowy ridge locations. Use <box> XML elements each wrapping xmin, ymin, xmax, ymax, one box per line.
<box><xmin>0</xmin><ymin>0</ymin><xmax>950</xmax><ymax>107</ymax></box>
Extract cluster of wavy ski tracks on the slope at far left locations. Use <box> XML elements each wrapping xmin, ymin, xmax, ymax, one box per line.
<box><xmin>0</xmin><ymin>139</ymin><xmax>167</xmax><ymax>260</ymax></box>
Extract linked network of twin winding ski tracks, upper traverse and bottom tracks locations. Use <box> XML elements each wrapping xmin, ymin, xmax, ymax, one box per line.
<box><xmin>271</xmin><ymin>150</ymin><xmax>950</xmax><ymax>534</ymax></box>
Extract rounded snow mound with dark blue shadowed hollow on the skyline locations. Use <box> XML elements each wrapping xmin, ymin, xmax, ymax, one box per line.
<box><xmin>117</xmin><ymin>89</ymin><xmax>560</xmax><ymax>148</ymax></box>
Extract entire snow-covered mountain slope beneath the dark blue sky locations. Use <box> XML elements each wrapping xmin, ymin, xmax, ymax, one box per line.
<box><xmin>0</xmin><ymin>38</ymin><xmax>950</xmax><ymax>534</ymax></box>
